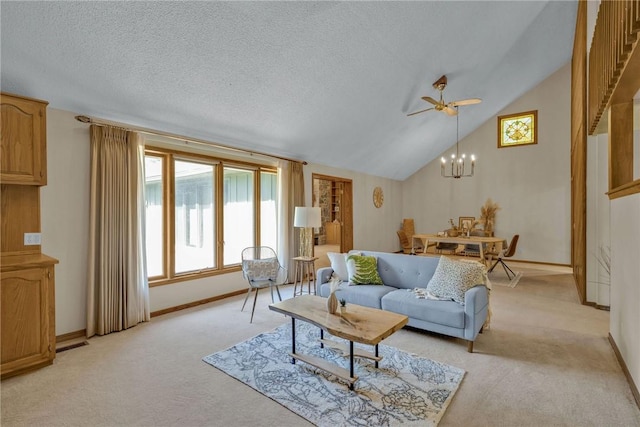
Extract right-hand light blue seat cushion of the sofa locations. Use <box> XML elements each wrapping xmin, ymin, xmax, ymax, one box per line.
<box><xmin>381</xmin><ymin>289</ymin><xmax>464</xmax><ymax>329</ymax></box>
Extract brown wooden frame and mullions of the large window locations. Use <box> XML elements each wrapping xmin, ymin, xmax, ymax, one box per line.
<box><xmin>144</xmin><ymin>144</ymin><xmax>278</xmax><ymax>287</ymax></box>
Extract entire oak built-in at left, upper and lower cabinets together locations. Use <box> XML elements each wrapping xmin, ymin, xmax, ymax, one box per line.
<box><xmin>0</xmin><ymin>93</ymin><xmax>58</xmax><ymax>378</ymax></box>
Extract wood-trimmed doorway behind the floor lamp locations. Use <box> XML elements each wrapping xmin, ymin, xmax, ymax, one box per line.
<box><xmin>312</xmin><ymin>174</ymin><xmax>353</xmax><ymax>265</ymax></box>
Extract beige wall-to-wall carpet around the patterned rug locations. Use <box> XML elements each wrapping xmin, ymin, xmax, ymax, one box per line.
<box><xmin>0</xmin><ymin>264</ymin><xmax>640</xmax><ymax>427</ymax></box>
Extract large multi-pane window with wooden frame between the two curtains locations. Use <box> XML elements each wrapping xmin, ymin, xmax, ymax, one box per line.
<box><xmin>145</xmin><ymin>147</ymin><xmax>278</xmax><ymax>286</ymax></box>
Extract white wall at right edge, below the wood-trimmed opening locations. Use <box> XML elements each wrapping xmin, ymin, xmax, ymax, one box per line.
<box><xmin>609</xmin><ymin>194</ymin><xmax>640</xmax><ymax>396</ymax></box>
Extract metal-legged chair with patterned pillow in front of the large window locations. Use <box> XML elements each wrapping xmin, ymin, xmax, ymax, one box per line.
<box><xmin>240</xmin><ymin>246</ymin><xmax>287</xmax><ymax>323</ymax></box>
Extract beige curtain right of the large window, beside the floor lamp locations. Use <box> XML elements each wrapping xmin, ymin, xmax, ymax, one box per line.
<box><xmin>278</xmin><ymin>161</ymin><xmax>304</xmax><ymax>282</ymax></box>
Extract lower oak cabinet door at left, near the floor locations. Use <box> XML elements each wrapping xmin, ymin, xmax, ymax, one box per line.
<box><xmin>0</xmin><ymin>267</ymin><xmax>55</xmax><ymax>378</ymax></box>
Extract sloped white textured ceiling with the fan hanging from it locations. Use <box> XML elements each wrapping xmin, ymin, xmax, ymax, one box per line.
<box><xmin>0</xmin><ymin>1</ymin><xmax>577</xmax><ymax>179</ymax></box>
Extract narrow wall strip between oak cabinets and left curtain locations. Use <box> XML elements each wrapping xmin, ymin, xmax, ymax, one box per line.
<box><xmin>40</xmin><ymin>108</ymin><xmax>90</xmax><ymax>335</ymax></box>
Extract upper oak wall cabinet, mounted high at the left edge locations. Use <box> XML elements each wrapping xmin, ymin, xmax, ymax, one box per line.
<box><xmin>0</xmin><ymin>93</ymin><xmax>48</xmax><ymax>185</ymax></box>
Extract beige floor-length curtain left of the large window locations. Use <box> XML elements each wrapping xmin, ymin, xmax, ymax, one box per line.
<box><xmin>87</xmin><ymin>125</ymin><xmax>150</xmax><ymax>337</ymax></box>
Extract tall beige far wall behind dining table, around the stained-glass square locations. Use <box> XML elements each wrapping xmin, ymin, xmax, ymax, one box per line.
<box><xmin>403</xmin><ymin>64</ymin><xmax>571</xmax><ymax>264</ymax></box>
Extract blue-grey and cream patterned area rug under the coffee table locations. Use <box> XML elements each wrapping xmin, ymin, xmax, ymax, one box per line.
<box><xmin>202</xmin><ymin>321</ymin><xmax>465</xmax><ymax>426</ymax></box>
